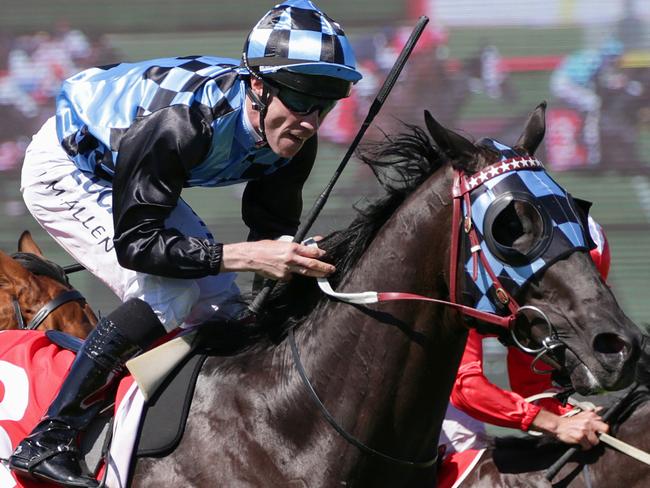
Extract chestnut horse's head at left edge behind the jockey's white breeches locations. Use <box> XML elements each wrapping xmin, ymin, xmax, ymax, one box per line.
<box><xmin>0</xmin><ymin>232</ymin><xmax>97</xmax><ymax>337</ymax></box>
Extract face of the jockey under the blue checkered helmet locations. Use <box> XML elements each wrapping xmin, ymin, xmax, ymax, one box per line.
<box><xmin>246</xmin><ymin>77</ymin><xmax>321</xmax><ymax>158</ymax></box>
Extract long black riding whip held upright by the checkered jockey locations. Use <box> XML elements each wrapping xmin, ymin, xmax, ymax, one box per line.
<box><xmin>248</xmin><ymin>15</ymin><xmax>429</xmax><ymax>314</ymax></box>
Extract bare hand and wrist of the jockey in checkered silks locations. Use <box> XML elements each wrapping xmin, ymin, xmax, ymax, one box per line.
<box><xmin>221</xmin><ymin>240</ymin><xmax>336</xmax><ymax>281</ymax></box>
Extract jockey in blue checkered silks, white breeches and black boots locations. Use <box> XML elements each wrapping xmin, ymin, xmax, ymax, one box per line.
<box><xmin>9</xmin><ymin>0</ymin><xmax>361</xmax><ymax>487</ymax></box>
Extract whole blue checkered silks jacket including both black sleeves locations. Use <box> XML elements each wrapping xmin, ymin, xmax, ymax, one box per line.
<box><xmin>50</xmin><ymin>56</ymin><xmax>317</xmax><ymax>278</ymax></box>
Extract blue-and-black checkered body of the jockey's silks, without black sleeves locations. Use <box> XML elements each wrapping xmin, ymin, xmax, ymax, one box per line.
<box><xmin>57</xmin><ymin>56</ymin><xmax>287</xmax><ymax>186</ymax></box>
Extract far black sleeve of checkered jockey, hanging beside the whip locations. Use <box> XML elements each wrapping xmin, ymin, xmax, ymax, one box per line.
<box><xmin>242</xmin><ymin>135</ymin><xmax>318</xmax><ymax>241</ymax></box>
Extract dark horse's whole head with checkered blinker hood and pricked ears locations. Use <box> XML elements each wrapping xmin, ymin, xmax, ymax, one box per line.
<box><xmin>425</xmin><ymin>104</ymin><xmax>641</xmax><ymax>393</ymax></box>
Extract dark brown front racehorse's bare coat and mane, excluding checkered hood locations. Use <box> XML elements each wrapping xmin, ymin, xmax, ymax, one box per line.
<box><xmin>125</xmin><ymin>105</ymin><xmax>640</xmax><ymax>488</ymax></box>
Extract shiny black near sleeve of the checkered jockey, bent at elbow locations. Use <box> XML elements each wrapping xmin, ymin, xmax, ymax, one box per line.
<box><xmin>113</xmin><ymin>105</ymin><xmax>223</xmax><ymax>278</ymax></box>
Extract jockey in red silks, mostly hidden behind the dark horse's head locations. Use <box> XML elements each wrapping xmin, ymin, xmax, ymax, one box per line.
<box><xmin>441</xmin><ymin>217</ymin><xmax>610</xmax><ymax>452</ymax></box>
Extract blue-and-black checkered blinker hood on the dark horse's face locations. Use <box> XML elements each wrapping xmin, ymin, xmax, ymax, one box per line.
<box><xmin>461</xmin><ymin>143</ymin><xmax>590</xmax><ymax>314</ymax></box>
